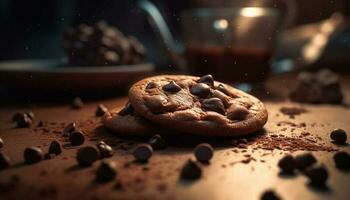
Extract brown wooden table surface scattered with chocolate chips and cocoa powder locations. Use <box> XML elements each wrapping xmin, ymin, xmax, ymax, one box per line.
<box><xmin>0</xmin><ymin>76</ymin><xmax>350</xmax><ymax>200</ymax></box>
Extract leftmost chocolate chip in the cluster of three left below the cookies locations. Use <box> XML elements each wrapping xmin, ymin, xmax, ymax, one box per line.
<box><xmin>76</xmin><ymin>146</ymin><xmax>100</xmax><ymax>166</ymax></box>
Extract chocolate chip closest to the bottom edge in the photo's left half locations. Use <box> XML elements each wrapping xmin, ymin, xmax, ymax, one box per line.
<box><xmin>96</xmin><ymin>160</ymin><xmax>117</xmax><ymax>182</ymax></box>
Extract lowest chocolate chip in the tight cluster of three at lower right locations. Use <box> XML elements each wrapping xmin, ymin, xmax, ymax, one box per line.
<box><xmin>305</xmin><ymin>165</ymin><xmax>328</xmax><ymax>186</ymax></box>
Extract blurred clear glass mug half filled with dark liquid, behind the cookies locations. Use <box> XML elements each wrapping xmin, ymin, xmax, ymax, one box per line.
<box><xmin>138</xmin><ymin>0</ymin><xmax>292</xmax><ymax>83</ymax></box>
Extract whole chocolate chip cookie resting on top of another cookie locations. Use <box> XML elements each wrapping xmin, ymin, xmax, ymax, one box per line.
<box><xmin>129</xmin><ymin>75</ymin><xmax>268</xmax><ymax>136</ymax></box>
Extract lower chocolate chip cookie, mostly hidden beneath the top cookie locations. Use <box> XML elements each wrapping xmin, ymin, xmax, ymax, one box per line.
<box><xmin>102</xmin><ymin>103</ymin><xmax>157</xmax><ymax>136</ymax></box>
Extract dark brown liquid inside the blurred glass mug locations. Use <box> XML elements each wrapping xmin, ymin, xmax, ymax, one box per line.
<box><xmin>186</xmin><ymin>47</ymin><xmax>272</xmax><ymax>83</ymax></box>
